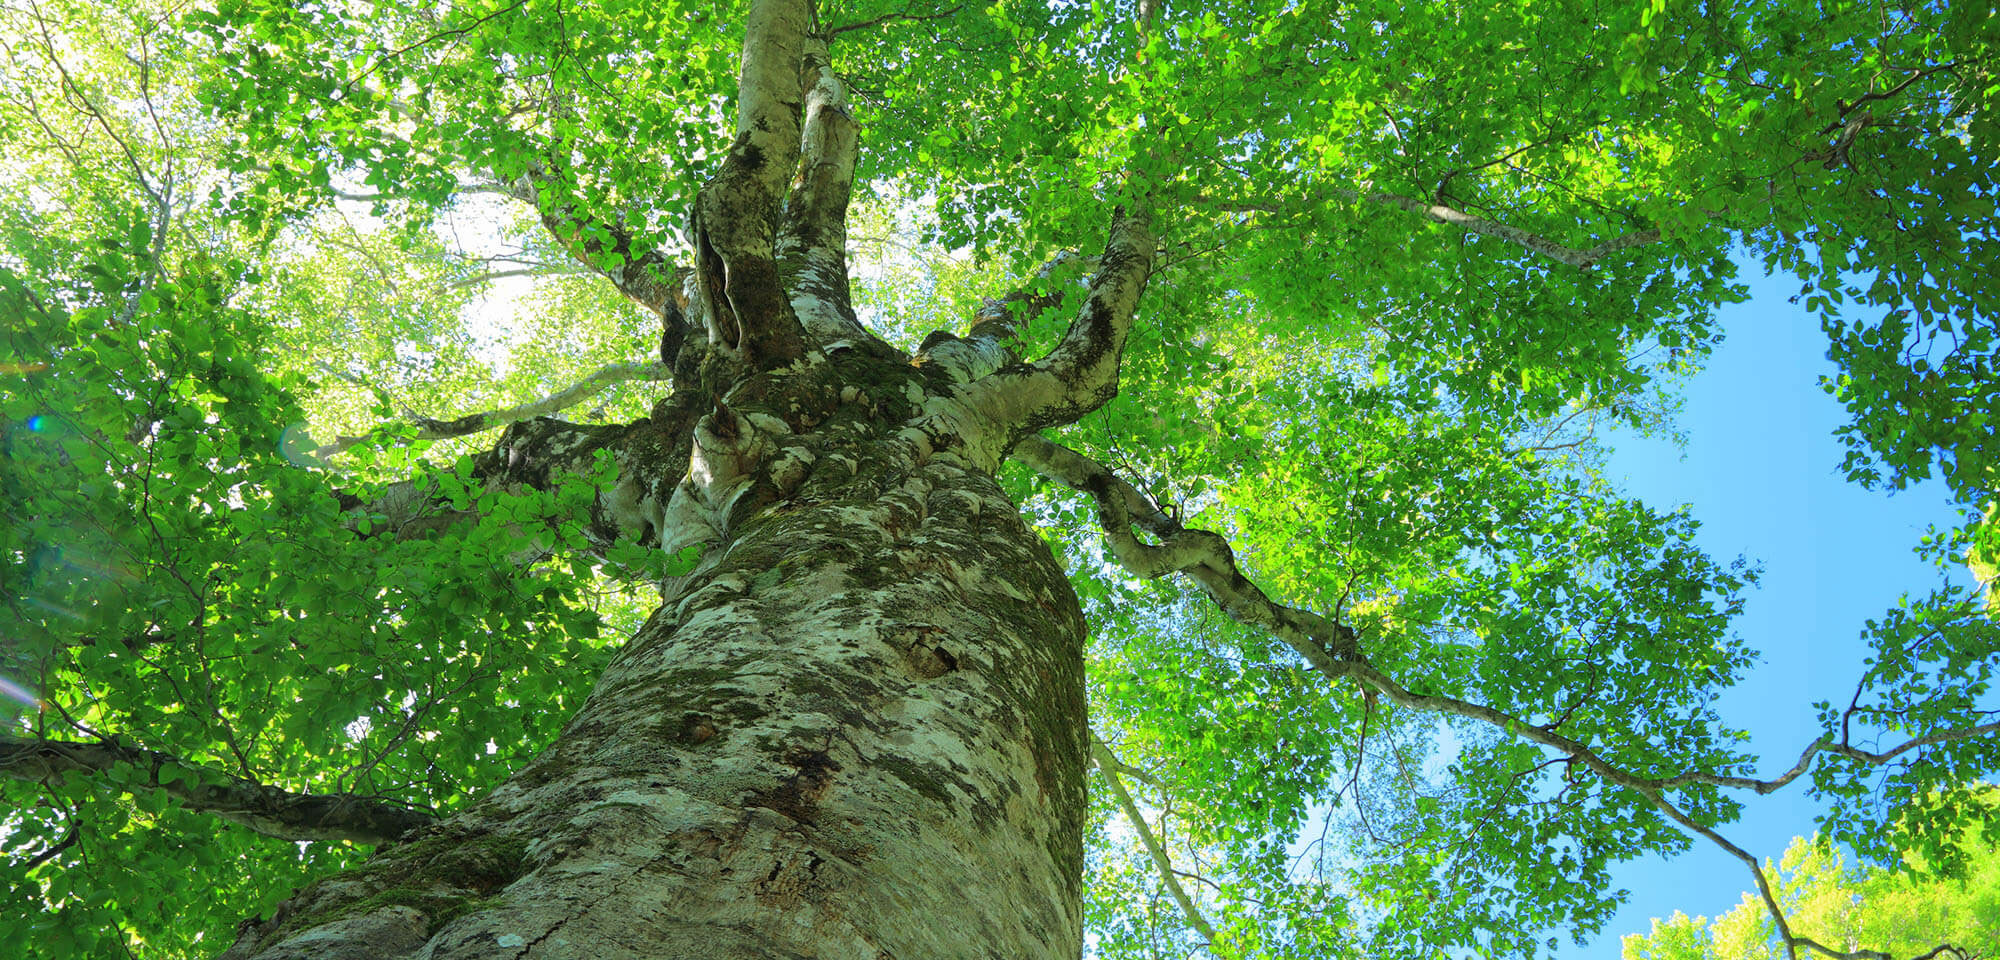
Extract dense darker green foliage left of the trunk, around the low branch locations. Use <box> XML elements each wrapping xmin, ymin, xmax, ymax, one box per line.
<box><xmin>0</xmin><ymin>231</ymin><xmax>602</xmax><ymax>956</ymax></box>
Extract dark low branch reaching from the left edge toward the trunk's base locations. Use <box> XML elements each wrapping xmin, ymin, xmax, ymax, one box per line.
<box><xmin>0</xmin><ymin>736</ymin><xmax>436</xmax><ymax>844</ymax></box>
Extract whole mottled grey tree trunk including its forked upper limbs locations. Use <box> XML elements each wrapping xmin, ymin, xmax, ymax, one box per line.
<box><xmin>224</xmin><ymin>0</ymin><xmax>1154</xmax><ymax>960</ymax></box>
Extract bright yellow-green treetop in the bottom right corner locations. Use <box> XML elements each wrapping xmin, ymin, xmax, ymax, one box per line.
<box><xmin>1624</xmin><ymin>804</ymin><xmax>2000</xmax><ymax>960</ymax></box>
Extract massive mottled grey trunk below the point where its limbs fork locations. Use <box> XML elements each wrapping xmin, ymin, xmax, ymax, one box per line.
<box><xmin>228</xmin><ymin>350</ymin><xmax>1088</xmax><ymax>960</ymax></box>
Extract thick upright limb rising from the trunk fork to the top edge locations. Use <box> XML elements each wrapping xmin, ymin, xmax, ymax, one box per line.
<box><xmin>692</xmin><ymin>0</ymin><xmax>808</xmax><ymax>368</ymax></box>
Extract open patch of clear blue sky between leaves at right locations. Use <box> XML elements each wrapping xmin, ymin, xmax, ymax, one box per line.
<box><xmin>1558</xmin><ymin>268</ymin><xmax>1956</xmax><ymax>960</ymax></box>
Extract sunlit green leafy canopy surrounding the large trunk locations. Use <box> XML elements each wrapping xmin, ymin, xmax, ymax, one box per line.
<box><xmin>0</xmin><ymin>0</ymin><xmax>2000</xmax><ymax>958</ymax></box>
